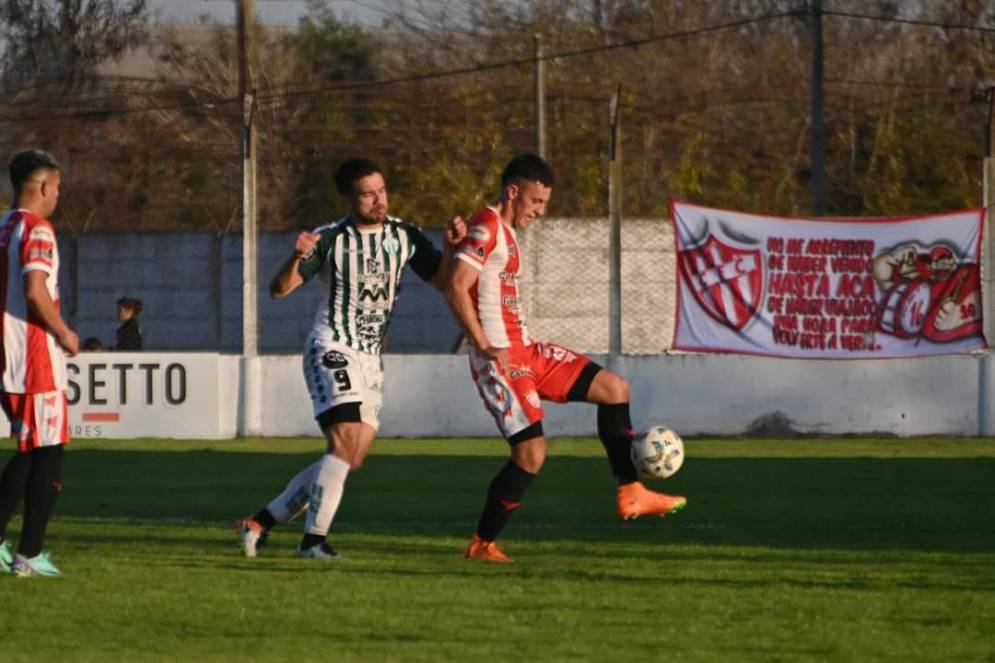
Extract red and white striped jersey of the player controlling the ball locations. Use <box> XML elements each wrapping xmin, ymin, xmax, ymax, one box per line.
<box><xmin>456</xmin><ymin>207</ymin><xmax>532</xmax><ymax>348</ymax></box>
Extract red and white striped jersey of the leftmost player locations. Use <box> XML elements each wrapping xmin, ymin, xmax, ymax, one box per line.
<box><xmin>0</xmin><ymin>209</ymin><xmax>67</xmax><ymax>394</ymax></box>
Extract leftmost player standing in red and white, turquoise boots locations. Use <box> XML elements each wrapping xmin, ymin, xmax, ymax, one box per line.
<box><xmin>0</xmin><ymin>150</ymin><xmax>79</xmax><ymax>576</ymax></box>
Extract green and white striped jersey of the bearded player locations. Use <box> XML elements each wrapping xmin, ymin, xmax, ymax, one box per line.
<box><xmin>299</xmin><ymin>216</ymin><xmax>441</xmax><ymax>355</ymax></box>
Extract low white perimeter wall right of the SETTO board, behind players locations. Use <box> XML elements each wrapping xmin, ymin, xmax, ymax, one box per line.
<box><xmin>253</xmin><ymin>355</ymin><xmax>992</xmax><ymax>437</ymax></box>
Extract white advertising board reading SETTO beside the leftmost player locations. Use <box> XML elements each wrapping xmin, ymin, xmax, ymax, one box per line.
<box><xmin>67</xmin><ymin>352</ymin><xmax>238</xmax><ymax>439</ymax></box>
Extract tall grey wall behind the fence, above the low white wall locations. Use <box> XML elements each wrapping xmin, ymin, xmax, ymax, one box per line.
<box><xmin>60</xmin><ymin>218</ymin><xmax>676</xmax><ymax>354</ymax></box>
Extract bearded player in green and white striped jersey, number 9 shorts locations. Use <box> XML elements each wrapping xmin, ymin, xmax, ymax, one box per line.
<box><xmin>236</xmin><ymin>159</ymin><xmax>466</xmax><ymax>559</ymax></box>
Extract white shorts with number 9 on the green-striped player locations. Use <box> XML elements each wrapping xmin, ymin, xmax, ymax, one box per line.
<box><xmin>304</xmin><ymin>332</ymin><xmax>383</xmax><ymax>430</ymax></box>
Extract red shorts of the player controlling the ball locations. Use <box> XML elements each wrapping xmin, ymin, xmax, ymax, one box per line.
<box><xmin>470</xmin><ymin>343</ymin><xmax>591</xmax><ymax>438</ymax></box>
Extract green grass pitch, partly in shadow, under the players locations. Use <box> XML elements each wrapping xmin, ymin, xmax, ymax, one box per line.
<box><xmin>0</xmin><ymin>439</ymin><xmax>995</xmax><ymax>663</ymax></box>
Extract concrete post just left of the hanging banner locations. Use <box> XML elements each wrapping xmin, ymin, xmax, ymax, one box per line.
<box><xmin>608</xmin><ymin>83</ymin><xmax>622</xmax><ymax>356</ymax></box>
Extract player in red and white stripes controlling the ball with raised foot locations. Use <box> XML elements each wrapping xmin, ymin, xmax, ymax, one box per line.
<box><xmin>446</xmin><ymin>154</ymin><xmax>687</xmax><ymax>562</ymax></box>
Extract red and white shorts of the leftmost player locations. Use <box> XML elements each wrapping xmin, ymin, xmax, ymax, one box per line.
<box><xmin>0</xmin><ymin>391</ymin><xmax>69</xmax><ymax>453</ymax></box>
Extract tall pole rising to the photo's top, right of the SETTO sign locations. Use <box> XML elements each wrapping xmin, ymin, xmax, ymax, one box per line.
<box><xmin>235</xmin><ymin>0</ymin><xmax>261</xmax><ymax>436</ymax></box>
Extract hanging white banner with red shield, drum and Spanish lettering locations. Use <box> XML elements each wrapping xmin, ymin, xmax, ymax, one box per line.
<box><xmin>670</xmin><ymin>201</ymin><xmax>985</xmax><ymax>359</ymax></box>
